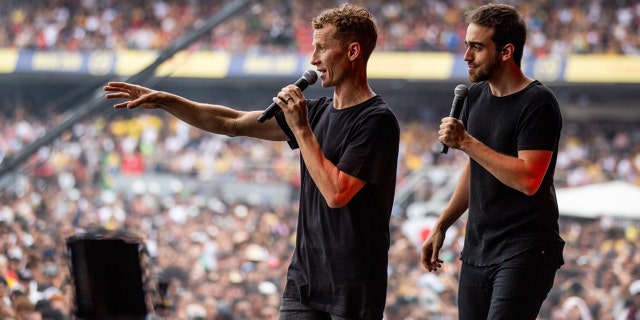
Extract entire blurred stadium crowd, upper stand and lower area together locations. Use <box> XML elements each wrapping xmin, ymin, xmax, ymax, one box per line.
<box><xmin>0</xmin><ymin>0</ymin><xmax>640</xmax><ymax>320</ymax></box>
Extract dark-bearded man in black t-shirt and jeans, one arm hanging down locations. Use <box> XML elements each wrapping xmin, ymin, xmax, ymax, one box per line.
<box><xmin>422</xmin><ymin>4</ymin><xmax>564</xmax><ymax>320</ymax></box>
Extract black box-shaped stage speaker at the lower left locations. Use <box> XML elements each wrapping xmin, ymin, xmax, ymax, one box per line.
<box><xmin>67</xmin><ymin>237</ymin><xmax>148</xmax><ymax>320</ymax></box>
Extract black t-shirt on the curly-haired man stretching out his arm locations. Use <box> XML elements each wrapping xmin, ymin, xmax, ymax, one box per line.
<box><xmin>276</xmin><ymin>96</ymin><xmax>400</xmax><ymax>319</ymax></box>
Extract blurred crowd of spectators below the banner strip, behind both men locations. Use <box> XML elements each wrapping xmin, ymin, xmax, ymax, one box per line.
<box><xmin>0</xmin><ymin>99</ymin><xmax>640</xmax><ymax>320</ymax></box>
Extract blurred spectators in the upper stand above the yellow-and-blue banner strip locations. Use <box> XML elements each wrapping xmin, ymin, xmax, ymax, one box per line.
<box><xmin>0</xmin><ymin>0</ymin><xmax>640</xmax><ymax>56</ymax></box>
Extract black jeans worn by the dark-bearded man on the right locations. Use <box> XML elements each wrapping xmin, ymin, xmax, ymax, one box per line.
<box><xmin>458</xmin><ymin>249</ymin><xmax>561</xmax><ymax>320</ymax></box>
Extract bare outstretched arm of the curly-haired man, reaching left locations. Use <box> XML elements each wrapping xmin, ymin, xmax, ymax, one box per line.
<box><xmin>104</xmin><ymin>82</ymin><xmax>287</xmax><ymax>141</ymax></box>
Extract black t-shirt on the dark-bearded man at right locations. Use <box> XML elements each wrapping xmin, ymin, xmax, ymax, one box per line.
<box><xmin>461</xmin><ymin>81</ymin><xmax>564</xmax><ymax>266</ymax></box>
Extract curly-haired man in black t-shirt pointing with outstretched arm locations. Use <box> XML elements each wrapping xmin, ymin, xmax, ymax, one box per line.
<box><xmin>104</xmin><ymin>4</ymin><xmax>400</xmax><ymax>320</ymax></box>
